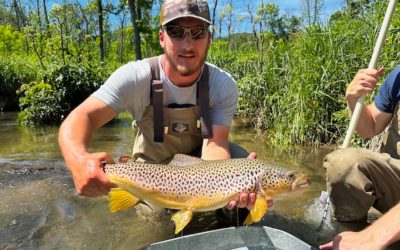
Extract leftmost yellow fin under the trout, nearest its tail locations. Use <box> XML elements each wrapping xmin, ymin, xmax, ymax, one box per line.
<box><xmin>108</xmin><ymin>188</ymin><xmax>139</xmax><ymax>213</ymax></box>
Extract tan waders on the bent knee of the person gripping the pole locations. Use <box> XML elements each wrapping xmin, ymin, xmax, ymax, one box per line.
<box><xmin>323</xmin><ymin>104</ymin><xmax>400</xmax><ymax>222</ymax></box>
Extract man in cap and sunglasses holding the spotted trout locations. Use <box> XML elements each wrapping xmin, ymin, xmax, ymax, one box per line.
<box><xmin>59</xmin><ymin>0</ymin><xmax>256</xmax><ymax>209</ymax></box>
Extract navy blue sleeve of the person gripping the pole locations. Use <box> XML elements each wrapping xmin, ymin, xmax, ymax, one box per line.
<box><xmin>375</xmin><ymin>67</ymin><xmax>400</xmax><ymax>113</ymax></box>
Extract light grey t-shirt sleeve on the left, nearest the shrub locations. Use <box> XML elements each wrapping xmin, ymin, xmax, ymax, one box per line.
<box><xmin>92</xmin><ymin>60</ymin><xmax>151</xmax><ymax>119</ymax></box>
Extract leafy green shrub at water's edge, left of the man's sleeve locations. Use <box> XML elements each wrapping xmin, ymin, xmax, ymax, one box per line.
<box><xmin>18</xmin><ymin>65</ymin><xmax>103</xmax><ymax>124</ymax></box>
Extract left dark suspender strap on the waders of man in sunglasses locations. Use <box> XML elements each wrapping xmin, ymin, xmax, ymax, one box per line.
<box><xmin>149</xmin><ymin>56</ymin><xmax>164</xmax><ymax>142</ymax></box>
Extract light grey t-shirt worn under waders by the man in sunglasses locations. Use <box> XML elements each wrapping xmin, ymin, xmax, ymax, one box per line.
<box><xmin>92</xmin><ymin>57</ymin><xmax>238</xmax><ymax>127</ymax></box>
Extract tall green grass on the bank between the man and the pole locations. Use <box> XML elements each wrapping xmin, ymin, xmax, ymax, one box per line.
<box><xmin>209</xmin><ymin>5</ymin><xmax>400</xmax><ymax>146</ymax></box>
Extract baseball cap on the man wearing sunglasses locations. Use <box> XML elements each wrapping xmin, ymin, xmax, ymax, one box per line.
<box><xmin>160</xmin><ymin>0</ymin><xmax>211</xmax><ymax>26</ymax></box>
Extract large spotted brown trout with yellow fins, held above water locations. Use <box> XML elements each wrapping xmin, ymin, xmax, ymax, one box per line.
<box><xmin>104</xmin><ymin>154</ymin><xmax>310</xmax><ymax>234</ymax></box>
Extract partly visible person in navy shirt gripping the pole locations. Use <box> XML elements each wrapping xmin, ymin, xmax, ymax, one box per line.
<box><xmin>321</xmin><ymin>68</ymin><xmax>400</xmax><ymax>249</ymax></box>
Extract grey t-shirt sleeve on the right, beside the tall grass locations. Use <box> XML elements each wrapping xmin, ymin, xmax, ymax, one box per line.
<box><xmin>210</xmin><ymin>67</ymin><xmax>238</xmax><ymax>127</ymax></box>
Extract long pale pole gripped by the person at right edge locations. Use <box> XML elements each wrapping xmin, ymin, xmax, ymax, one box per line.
<box><xmin>342</xmin><ymin>0</ymin><xmax>397</xmax><ymax>148</ymax></box>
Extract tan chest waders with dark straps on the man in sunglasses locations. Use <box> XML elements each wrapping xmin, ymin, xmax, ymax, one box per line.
<box><xmin>133</xmin><ymin>56</ymin><xmax>213</xmax><ymax>162</ymax></box>
